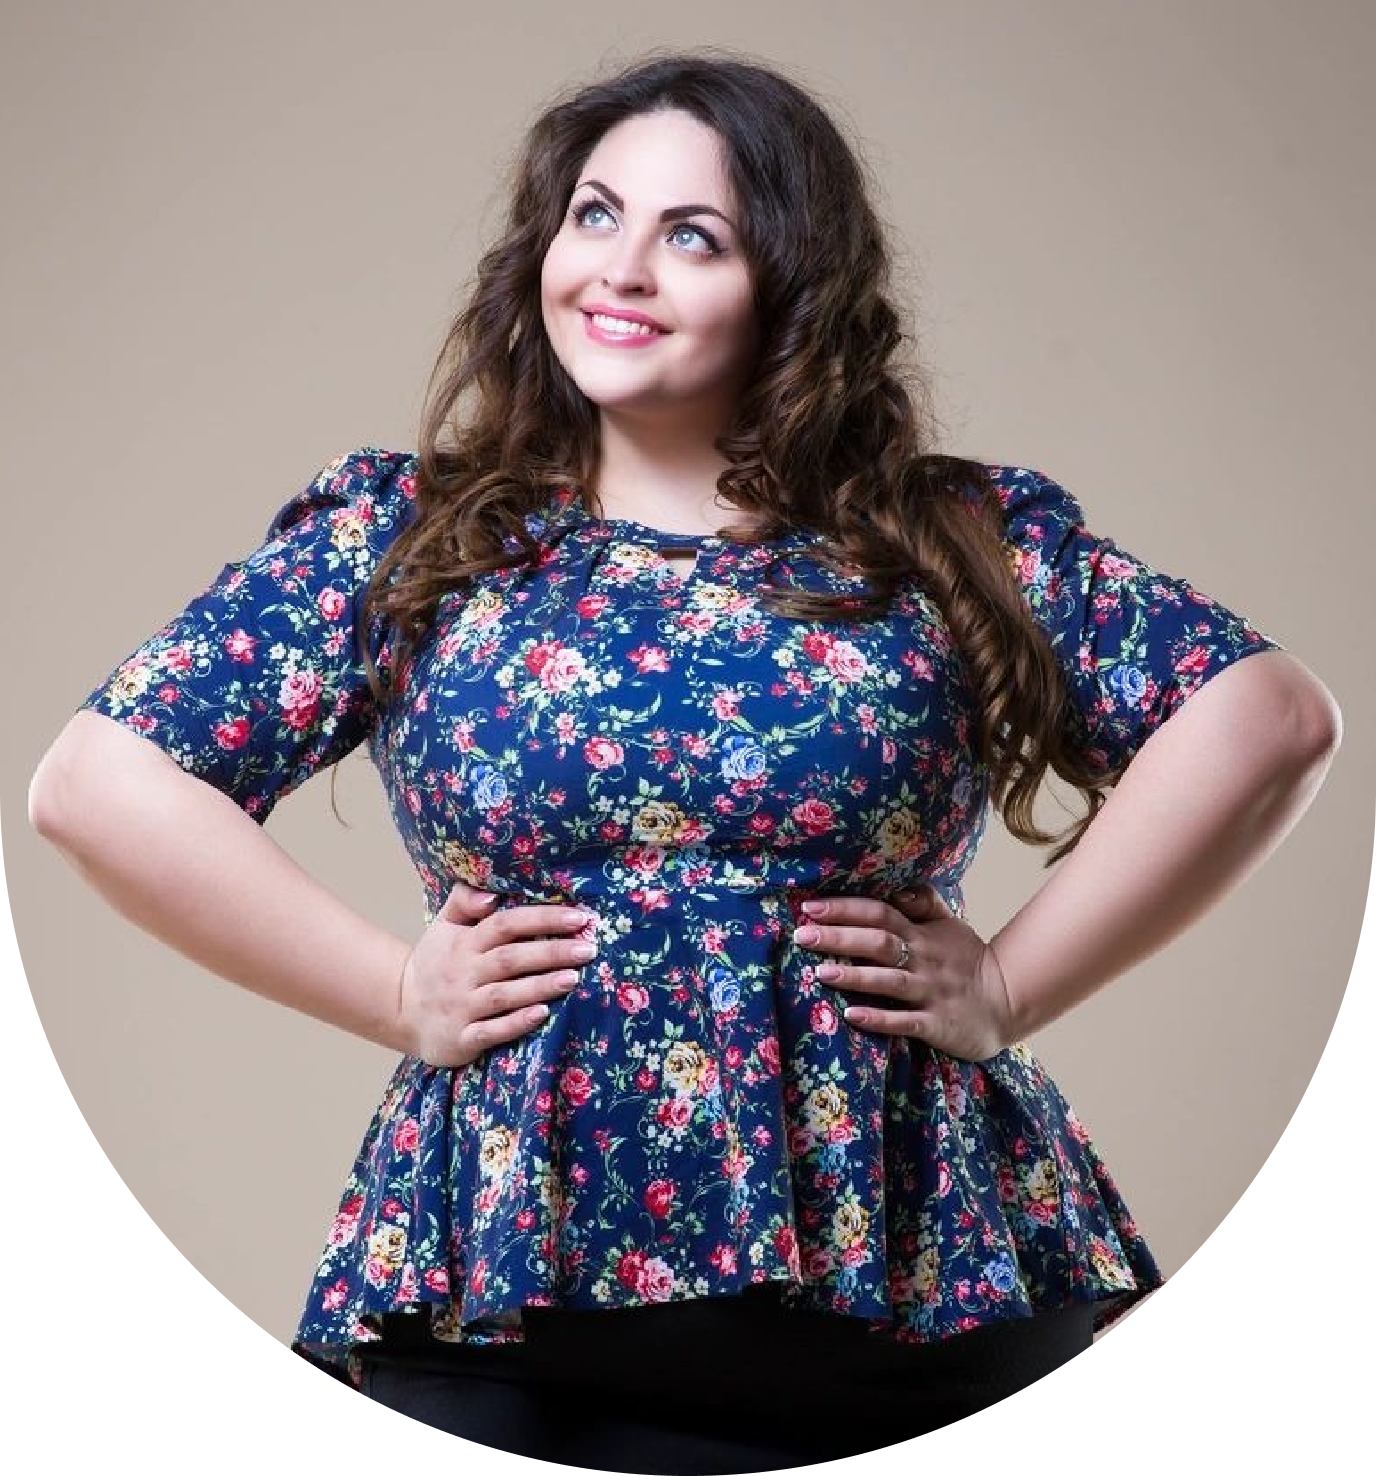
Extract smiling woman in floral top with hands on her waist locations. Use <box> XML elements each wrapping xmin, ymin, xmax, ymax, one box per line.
<box><xmin>31</xmin><ymin>55</ymin><xmax>1341</xmax><ymax>1472</ymax></box>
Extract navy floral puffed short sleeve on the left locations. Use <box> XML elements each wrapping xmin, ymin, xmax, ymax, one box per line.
<box><xmin>81</xmin><ymin>447</ymin><xmax>415</xmax><ymax>824</ymax></box>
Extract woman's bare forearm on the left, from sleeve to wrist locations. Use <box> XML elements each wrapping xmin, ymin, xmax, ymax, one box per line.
<box><xmin>28</xmin><ymin>711</ymin><xmax>410</xmax><ymax>1051</ymax></box>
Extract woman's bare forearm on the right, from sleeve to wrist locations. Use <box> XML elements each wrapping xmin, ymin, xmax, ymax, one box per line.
<box><xmin>989</xmin><ymin>651</ymin><xmax>1342</xmax><ymax>1039</ymax></box>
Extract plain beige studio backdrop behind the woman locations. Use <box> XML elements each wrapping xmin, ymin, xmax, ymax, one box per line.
<box><xmin>0</xmin><ymin>0</ymin><xmax>1376</xmax><ymax>1342</ymax></box>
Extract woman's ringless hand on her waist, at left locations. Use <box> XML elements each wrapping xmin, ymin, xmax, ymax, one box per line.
<box><xmin>399</xmin><ymin>881</ymin><xmax>595</xmax><ymax>1067</ymax></box>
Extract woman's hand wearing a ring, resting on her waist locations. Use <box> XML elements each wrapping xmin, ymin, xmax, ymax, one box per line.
<box><xmin>793</xmin><ymin>886</ymin><xmax>1017</xmax><ymax>1061</ymax></box>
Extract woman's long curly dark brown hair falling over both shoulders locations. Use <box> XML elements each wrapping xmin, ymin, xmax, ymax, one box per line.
<box><xmin>360</xmin><ymin>49</ymin><xmax>1116</xmax><ymax>865</ymax></box>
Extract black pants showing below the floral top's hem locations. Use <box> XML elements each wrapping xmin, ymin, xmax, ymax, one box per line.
<box><xmin>362</xmin><ymin>1287</ymin><xmax>1094</xmax><ymax>1476</ymax></box>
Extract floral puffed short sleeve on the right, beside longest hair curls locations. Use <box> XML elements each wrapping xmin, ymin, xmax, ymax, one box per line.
<box><xmin>989</xmin><ymin>466</ymin><xmax>1282</xmax><ymax>772</ymax></box>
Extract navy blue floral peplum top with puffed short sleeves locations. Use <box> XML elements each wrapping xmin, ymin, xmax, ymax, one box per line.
<box><xmin>83</xmin><ymin>447</ymin><xmax>1277</xmax><ymax>1382</ymax></box>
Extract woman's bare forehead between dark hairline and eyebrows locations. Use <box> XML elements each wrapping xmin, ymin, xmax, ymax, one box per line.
<box><xmin>579</xmin><ymin>111</ymin><xmax>731</xmax><ymax>205</ymax></box>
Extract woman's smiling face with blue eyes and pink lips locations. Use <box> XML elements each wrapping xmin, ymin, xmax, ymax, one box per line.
<box><xmin>540</xmin><ymin>111</ymin><xmax>757</xmax><ymax>434</ymax></box>
